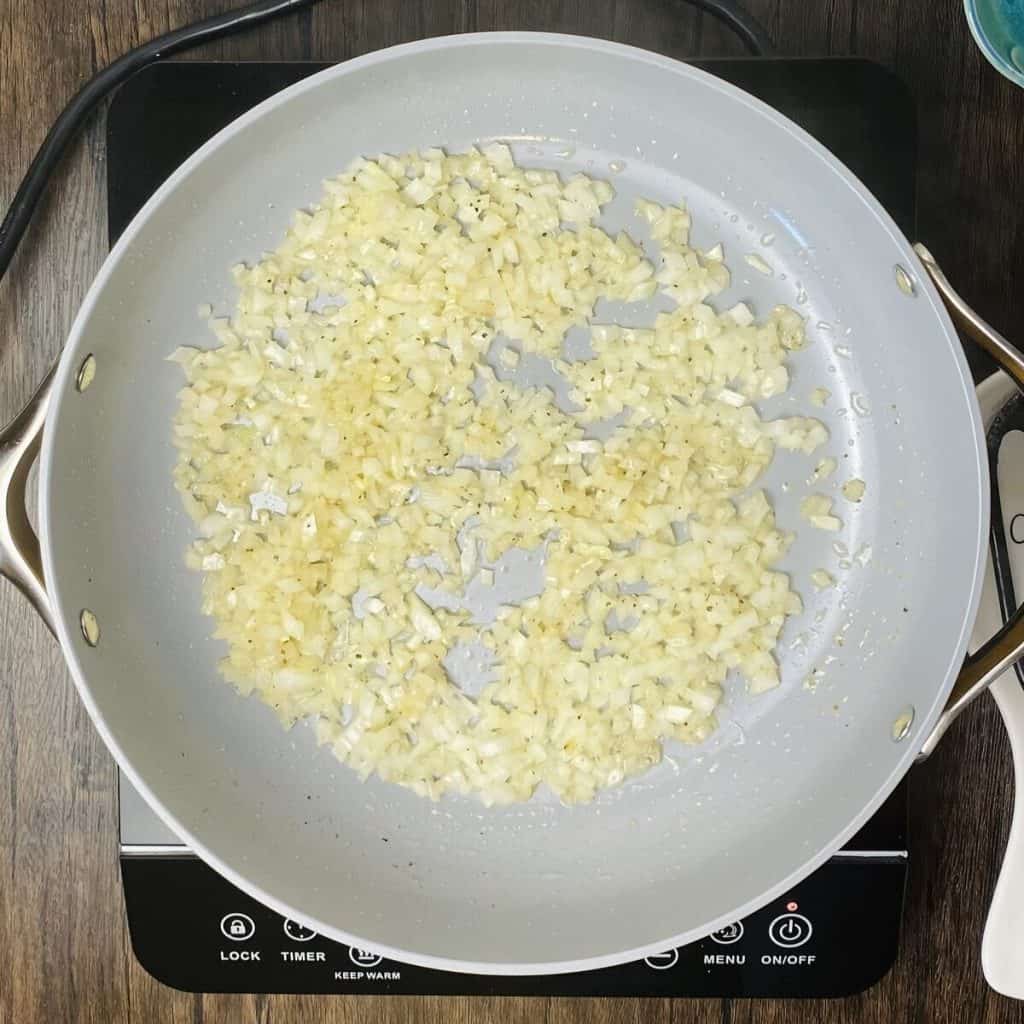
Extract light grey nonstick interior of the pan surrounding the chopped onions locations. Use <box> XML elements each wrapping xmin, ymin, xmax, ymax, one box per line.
<box><xmin>41</xmin><ymin>34</ymin><xmax>988</xmax><ymax>973</ymax></box>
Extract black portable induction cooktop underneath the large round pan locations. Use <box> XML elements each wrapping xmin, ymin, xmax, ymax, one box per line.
<box><xmin>106</xmin><ymin>58</ymin><xmax>915</xmax><ymax>997</ymax></box>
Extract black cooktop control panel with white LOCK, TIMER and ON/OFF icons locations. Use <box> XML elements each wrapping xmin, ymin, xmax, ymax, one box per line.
<box><xmin>121</xmin><ymin>854</ymin><xmax>906</xmax><ymax>997</ymax></box>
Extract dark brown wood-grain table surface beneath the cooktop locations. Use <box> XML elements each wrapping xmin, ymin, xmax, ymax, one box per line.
<box><xmin>0</xmin><ymin>0</ymin><xmax>1024</xmax><ymax>1024</ymax></box>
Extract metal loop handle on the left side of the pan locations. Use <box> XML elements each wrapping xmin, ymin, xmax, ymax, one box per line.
<box><xmin>0</xmin><ymin>368</ymin><xmax>56</xmax><ymax>634</ymax></box>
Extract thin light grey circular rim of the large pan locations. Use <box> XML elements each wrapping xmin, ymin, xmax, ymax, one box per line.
<box><xmin>39</xmin><ymin>32</ymin><xmax>989</xmax><ymax>976</ymax></box>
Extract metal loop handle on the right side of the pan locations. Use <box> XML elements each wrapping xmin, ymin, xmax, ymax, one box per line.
<box><xmin>913</xmin><ymin>243</ymin><xmax>1024</xmax><ymax>757</ymax></box>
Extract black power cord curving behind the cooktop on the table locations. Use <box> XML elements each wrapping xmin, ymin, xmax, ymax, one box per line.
<box><xmin>0</xmin><ymin>0</ymin><xmax>771</xmax><ymax>288</ymax></box>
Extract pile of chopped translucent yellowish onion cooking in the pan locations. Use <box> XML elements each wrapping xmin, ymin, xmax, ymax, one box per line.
<box><xmin>173</xmin><ymin>144</ymin><xmax>827</xmax><ymax>804</ymax></box>
